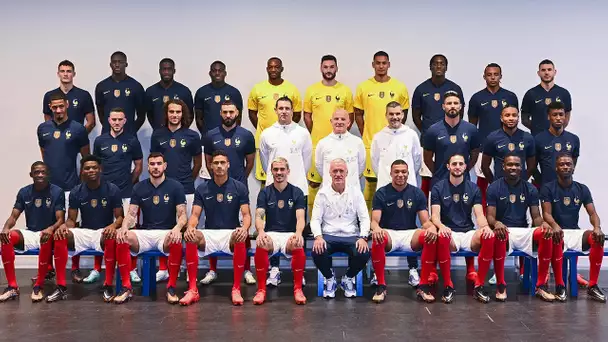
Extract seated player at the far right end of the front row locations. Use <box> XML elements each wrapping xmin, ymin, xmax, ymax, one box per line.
<box><xmin>540</xmin><ymin>153</ymin><xmax>606</xmax><ymax>303</ymax></box>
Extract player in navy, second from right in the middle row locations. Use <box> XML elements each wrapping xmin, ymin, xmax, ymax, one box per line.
<box><xmin>481</xmin><ymin>105</ymin><xmax>536</xmax><ymax>183</ymax></box>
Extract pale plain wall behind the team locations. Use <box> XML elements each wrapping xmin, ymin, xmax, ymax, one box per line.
<box><xmin>0</xmin><ymin>0</ymin><xmax>608</xmax><ymax>268</ymax></box>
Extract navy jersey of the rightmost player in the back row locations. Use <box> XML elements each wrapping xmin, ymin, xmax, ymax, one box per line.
<box><xmin>521</xmin><ymin>84</ymin><xmax>572</xmax><ymax>136</ymax></box>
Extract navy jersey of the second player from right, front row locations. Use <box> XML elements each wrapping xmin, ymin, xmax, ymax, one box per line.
<box><xmin>486</xmin><ymin>178</ymin><xmax>539</xmax><ymax>228</ymax></box>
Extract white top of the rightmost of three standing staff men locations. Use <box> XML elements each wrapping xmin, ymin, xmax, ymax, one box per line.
<box><xmin>370</xmin><ymin>125</ymin><xmax>422</xmax><ymax>190</ymax></box>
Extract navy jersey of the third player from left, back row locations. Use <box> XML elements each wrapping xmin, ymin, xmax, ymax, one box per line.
<box><xmin>146</xmin><ymin>81</ymin><xmax>194</xmax><ymax>129</ymax></box>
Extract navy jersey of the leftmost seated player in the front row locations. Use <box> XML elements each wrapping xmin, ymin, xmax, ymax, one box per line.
<box><xmin>13</xmin><ymin>184</ymin><xmax>65</xmax><ymax>232</ymax></box>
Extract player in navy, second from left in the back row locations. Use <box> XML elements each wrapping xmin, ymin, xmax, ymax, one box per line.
<box><xmin>95</xmin><ymin>51</ymin><xmax>146</xmax><ymax>134</ymax></box>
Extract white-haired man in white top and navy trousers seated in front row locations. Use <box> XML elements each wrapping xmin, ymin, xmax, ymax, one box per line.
<box><xmin>310</xmin><ymin>159</ymin><xmax>370</xmax><ymax>298</ymax></box>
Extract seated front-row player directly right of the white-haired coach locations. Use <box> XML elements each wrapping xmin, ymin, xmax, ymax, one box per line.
<box><xmin>371</xmin><ymin>159</ymin><xmax>437</xmax><ymax>303</ymax></box>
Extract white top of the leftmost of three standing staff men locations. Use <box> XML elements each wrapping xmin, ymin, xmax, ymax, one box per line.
<box><xmin>260</xmin><ymin>122</ymin><xmax>312</xmax><ymax>196</ymax></box>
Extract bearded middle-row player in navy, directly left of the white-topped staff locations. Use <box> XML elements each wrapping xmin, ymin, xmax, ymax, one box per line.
<box><xmin>201</xmin><ymin>100</ymin><xmax>255</xmax><ymax>285</ymax></box>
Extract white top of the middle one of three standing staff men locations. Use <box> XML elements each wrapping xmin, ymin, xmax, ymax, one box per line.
<box><xmin>315</xmin><ymin>132</ymin><xmax>365</xmax><ymax>189</ymax></box>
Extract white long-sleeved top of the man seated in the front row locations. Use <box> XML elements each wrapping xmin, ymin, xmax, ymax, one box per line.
<box><xmin>310</xmin><ymin>185</ymin><xmax>370</xmax><ymax>237</ymax></box>
